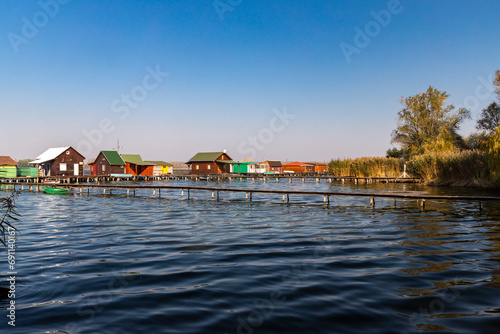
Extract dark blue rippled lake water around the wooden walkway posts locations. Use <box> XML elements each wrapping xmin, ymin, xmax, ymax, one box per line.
<box><xmin>0</xmin><ymin>181</ymin><xmax>500</xmax><ymax>334</ymax></box>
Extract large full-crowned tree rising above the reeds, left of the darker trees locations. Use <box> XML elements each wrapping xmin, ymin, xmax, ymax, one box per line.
<box><xmin>391</xmin><ymin>86</ymin><xmax>470</xmax><ymax>157</ymax></box>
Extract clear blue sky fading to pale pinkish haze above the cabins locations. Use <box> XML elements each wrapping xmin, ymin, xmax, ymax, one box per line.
<box><xmin>0</xmin><ymin>0</ymin><xmax>500</xmax><ymax>161</ymax></box>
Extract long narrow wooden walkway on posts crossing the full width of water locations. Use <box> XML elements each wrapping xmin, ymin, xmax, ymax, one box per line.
<box><xmin>3</xmin><ymin>183</ymin><xmax>500</xmax><ymax>210</ymax></box>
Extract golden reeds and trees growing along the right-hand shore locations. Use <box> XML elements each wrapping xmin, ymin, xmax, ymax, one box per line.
<box><xmin>328</xmin><ymin>71</ymin><xmax>500</xmax><ymax>189</ymax></box>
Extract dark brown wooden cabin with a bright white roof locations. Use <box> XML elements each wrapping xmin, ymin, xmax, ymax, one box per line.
<box><xmin>30</xmin><ymin>146</ymin><xmax>85</xmax><ymax>176</ymax></box>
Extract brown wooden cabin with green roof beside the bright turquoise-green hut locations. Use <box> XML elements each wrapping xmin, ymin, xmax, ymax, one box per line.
<box><xmin>186</xmin><ymin>152</ymin><xmax>235</xmax><ymax>174</ymax></box>
